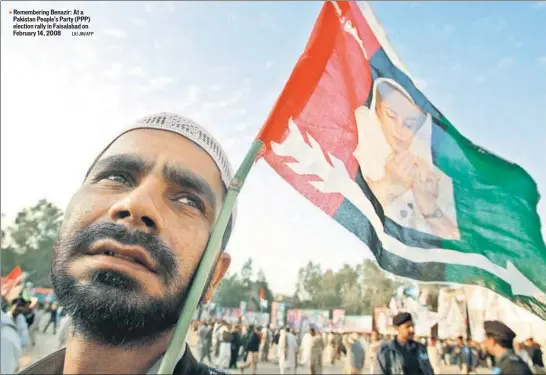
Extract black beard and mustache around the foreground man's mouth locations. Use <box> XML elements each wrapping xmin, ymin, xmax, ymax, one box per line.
<box><xmin>51</xmin><ymin>223</ymin><xmax>187</xmax><ymax>346</ymax></box>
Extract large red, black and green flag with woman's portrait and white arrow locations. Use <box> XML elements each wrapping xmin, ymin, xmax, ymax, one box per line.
<box><xmin>257</xmin><ymin>1</ymin><xmax>546</xmax><ymax>319</ymax></box>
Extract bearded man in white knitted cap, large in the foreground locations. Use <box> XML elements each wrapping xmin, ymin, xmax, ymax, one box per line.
<box><xmin>19</xmin><ymin>113</ymin><xmax>233</xmax><ymax>374</ymax></box>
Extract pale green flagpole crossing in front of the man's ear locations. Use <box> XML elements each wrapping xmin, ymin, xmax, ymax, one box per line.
<box><xmin>158</xmin><ymin>139</ymin><xmax>263</xmax><ymax>374</ymax></box>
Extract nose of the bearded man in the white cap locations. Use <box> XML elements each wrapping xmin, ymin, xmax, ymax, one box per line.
<box><xmin>108</xmin><ymin>183</ymin><xmax>163</xmax><ymax>234</ymax></box>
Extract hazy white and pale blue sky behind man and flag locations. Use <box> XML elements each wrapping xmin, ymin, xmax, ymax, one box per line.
<box><xmin>1</xmin><ymin>1</ymin><xmax>546</xmax><ymax>293</ymax></box>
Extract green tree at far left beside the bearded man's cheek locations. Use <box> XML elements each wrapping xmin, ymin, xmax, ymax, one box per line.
<box><xmin>2</xmin><ymin>199</ymin><xmax>63</xmax><ymax>287</ymax></box>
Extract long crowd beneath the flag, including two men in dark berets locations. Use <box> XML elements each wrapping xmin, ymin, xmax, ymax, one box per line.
<box><xmin>189</xmin><ymin>313</ymin><xmax>544</xmax><ymax>375</ymax></box>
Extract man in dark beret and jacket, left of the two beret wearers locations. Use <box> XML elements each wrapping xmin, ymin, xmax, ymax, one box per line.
<box><xmin>374</xmin><ymin>312</ymin><xmax>434</xmax><ymax>375</ymax></box>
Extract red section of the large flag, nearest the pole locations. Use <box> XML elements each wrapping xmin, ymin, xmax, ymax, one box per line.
<box><xmin>257</xmin><ymin>2</ymin><xmax>380</xmax><ymax>216</ymax></box>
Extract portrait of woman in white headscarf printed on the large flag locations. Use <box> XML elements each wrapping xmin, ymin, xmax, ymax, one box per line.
<box><xmin>354</xmin><ymin>78</ymin><xmax>459</xmax><ymax>239</ymax></box>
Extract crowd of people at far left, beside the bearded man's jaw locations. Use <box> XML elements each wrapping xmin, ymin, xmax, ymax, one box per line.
<box><xmin>1</xmin><ymin>297</ymin><xmax>69</xmax><ymax>374</ymax></box>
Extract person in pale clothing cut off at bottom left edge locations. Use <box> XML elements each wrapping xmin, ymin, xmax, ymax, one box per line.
<box><xmin>0</xmin><ymin>310</ymin><xmax>22</xmax><ymax>374</ymax></box>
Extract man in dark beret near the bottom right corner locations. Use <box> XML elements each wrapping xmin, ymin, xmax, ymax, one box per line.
<box><xmin>483</xmin><ymin>320</ymin><xmax>532</xmax><ymax>375</ymax></box>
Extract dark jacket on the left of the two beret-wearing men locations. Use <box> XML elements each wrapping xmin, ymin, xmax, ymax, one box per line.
<box><xmin>374</xmin><ymin>338</ymin><xmax>434</xmax><ymax>375</ymax></box>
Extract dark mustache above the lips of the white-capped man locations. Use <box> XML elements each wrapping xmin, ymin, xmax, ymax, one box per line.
<box><xmin>68</xmin><ymin>222</ymin><xmax>178</xmax><ymax>281</ymax></box>
